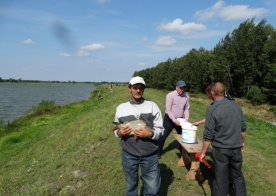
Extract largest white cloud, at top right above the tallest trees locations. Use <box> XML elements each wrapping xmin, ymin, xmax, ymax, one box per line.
<box><xmin>195</xmin><ymin>1</ymin><xmax>268</xmax><ymax>21</ymax></box>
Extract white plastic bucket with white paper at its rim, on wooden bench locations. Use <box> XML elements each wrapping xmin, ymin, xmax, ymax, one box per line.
<box><xmin>178</xmin><ymin>118</ymin><xmax>197</xmax><ymax>144</ymax></box>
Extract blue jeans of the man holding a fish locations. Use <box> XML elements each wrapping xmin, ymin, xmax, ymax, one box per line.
<box><xmin>122</xmin><ymin>150</ymin><xmax>161</xmax><ymax>196</ymax></box>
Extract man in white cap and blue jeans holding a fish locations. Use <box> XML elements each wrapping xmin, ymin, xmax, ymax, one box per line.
<box><xmin>114</xmin><ymin>76</ymin><xmax>164</xmax><ymax>195</ymax></box>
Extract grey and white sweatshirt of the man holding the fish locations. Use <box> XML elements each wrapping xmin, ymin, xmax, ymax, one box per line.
<box><xmin>114</xmin><ymin>100</ymin><xmax>164</xmax><ymax>156</ymax></box>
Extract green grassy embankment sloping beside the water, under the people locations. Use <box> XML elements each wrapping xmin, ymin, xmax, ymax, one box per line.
<box><xmin>0</xmin><ymin>86</ymin><xmax>276</xmax><ymax>196</ymax></box>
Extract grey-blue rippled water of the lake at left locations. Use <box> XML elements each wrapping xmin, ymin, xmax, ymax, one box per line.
<box><xmin>0</xmin><ymin>83</ymin><xmax>95</xmax><ymax>123</ymax></box>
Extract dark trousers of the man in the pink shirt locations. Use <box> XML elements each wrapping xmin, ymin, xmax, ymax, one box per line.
<box><xmin>159</xmin><ymin>114</ymin><xmax>182</xmax><ymax>154</ymax></box>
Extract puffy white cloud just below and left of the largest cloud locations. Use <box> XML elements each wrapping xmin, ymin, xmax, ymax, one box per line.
<box><xmin>159</xmin><ymin>18</ymin><xmax>206</xmax><ymax>35</ymax></box>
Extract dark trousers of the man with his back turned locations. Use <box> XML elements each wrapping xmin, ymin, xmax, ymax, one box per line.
<box><xmin>212</xmin><ymin>147</ymin><xmax>246</xmax><ymax>196</ymax></box>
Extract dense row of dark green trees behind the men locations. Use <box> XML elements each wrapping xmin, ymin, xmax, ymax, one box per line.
<box><xmin>133</xmin><ymin>18</ymin><xmax>276</xmax><ymax>104</ymax></box>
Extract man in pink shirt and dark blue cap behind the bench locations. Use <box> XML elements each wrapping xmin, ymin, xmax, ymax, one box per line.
<box><xmin>159</xmin><ymin>80</ymin><xmax>190</xmax><ymax>157</ymax></box>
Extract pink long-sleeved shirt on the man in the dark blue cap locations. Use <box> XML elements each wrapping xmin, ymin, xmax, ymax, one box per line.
<box><xmin>165</xmin><ymin>90</ymin><xmax>190</xmax><ymax>122</ymax></box>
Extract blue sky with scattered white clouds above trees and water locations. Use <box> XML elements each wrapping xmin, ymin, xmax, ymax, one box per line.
<box><xmin>0</xmin><ymin>0</ymin><xmax>276</xmax><ymax>82</ymax></box>
